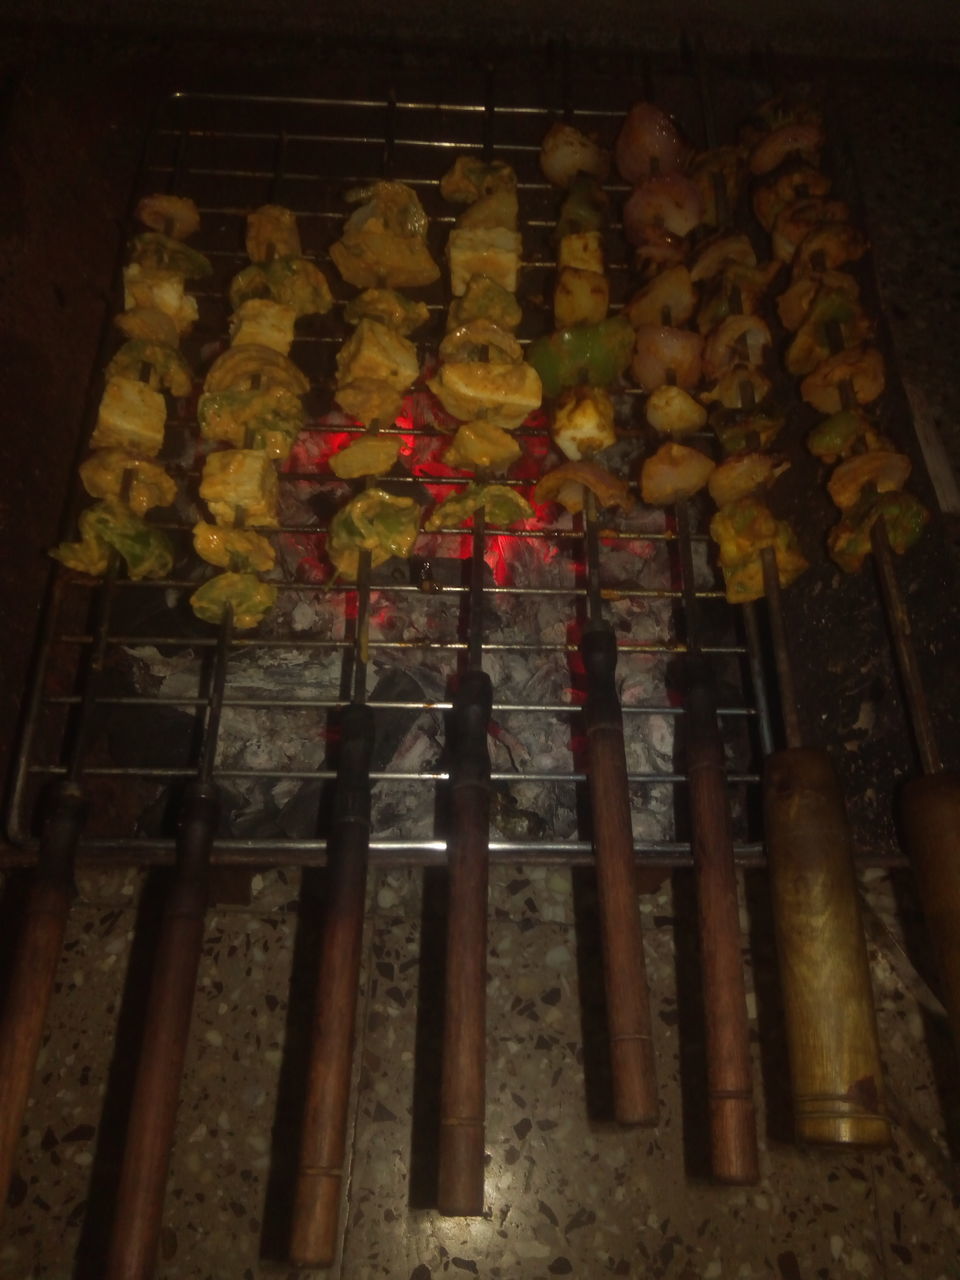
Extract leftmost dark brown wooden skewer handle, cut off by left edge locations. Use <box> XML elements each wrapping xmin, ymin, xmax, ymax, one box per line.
<box><xmin>0</xmin><ymin>782</ymin><xmax>84</xmax><ymax>1204</ymax></box>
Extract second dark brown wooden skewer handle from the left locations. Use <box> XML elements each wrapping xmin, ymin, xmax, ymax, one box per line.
<box><xmin>106</xmin><ymin>783</ymin><xmax>219</xmax><ymax>1280</ymax></box>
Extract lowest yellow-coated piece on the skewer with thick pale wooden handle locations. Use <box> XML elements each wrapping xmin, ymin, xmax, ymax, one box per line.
<box><xmin>710</xmin><ymin>498</ymin><xmax>809</xmax><ymax>604</ymax></box>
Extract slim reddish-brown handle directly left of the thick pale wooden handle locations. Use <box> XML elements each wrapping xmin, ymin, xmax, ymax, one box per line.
<box><xmin>686</xmin><ymin>675</ymin><xmax>760</xmax><ymax>1183</ymax></box>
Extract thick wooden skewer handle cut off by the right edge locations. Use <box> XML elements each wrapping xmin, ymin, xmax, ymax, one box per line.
<box><xmin>900</xmin><ymin>773</ymin><xmax>960</xmax><ymax>1053</ymax></box>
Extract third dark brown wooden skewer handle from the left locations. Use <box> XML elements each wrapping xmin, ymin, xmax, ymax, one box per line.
<box><xmin>291</xmin><ymin>703</ymin><xmax>374</xmax><ymax>1267</ymax></box>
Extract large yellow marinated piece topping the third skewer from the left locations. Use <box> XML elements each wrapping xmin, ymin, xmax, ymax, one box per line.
<box><xmin>330</xmin><ymin>182</ymin><xmax>440</xmax><ymax>289</ymax></box>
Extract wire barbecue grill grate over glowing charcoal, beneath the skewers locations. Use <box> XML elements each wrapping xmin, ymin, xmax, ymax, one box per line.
<box><xmin>5</xmin><ymin>35</ymin><xmax>960</xmax><ymax>1280</ymax></box>
